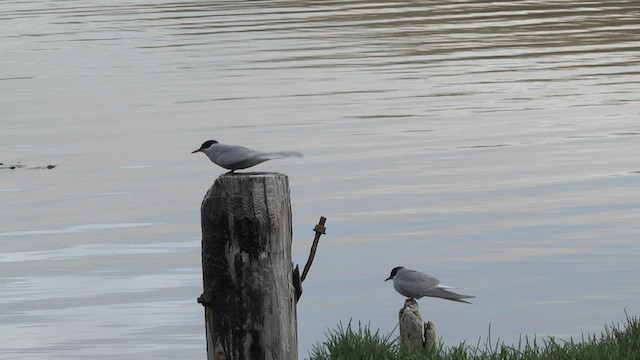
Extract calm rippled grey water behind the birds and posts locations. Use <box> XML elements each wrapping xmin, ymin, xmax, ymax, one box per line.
<box><xmin>0</xmin><ymin>0</ymin><xmax>640</xmax><ymax>359</ymax></box>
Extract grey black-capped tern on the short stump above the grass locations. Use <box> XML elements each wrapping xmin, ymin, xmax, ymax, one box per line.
<box><xmin>385</xmin><ymin>266</ymin><xmax>475</xmax><ymax>304</ymax></box>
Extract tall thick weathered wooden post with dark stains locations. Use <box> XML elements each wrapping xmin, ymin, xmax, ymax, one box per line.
<box><xmin>198</xmin><ymin>173</ymin><xmax>298</xmax><ymax>360</ymax></box>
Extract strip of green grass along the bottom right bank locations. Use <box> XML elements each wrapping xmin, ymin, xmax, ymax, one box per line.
<box><xmin>309</xmin><ymin>315</ymin><xmax>640</xmax><ymax>360</ymax></box>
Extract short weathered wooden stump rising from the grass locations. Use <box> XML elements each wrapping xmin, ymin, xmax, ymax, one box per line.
<box><xmin>398</xmin><ymin>299</ymin><xmax>436</xmax><ymax>351</ymax></box>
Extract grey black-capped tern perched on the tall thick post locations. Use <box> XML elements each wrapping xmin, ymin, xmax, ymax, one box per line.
<box><xmin>191</xmin><ymin>140</ymin><xmax>302</xmax><ymax>174</ymax></box>
